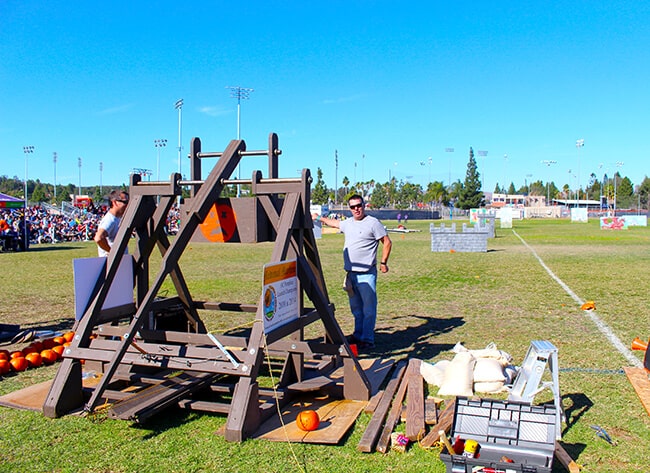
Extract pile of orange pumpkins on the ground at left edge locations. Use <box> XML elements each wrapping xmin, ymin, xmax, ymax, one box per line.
<box><xmin>0</xmin><ymin>332</ymin><xmax>74</xmax><ymax>376</ymax></box>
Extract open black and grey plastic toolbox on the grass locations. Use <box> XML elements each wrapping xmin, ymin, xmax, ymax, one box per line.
<box><xmin>440</xmin><ymin>397</ymin><xmax>556</xmax><ymax>473</ymax></box>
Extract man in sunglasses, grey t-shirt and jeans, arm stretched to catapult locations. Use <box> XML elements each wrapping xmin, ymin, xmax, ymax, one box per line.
<box><xmin>316</xmin><ymin>194</ymin><xmax>392</xmax><ymax>350</ymax></box>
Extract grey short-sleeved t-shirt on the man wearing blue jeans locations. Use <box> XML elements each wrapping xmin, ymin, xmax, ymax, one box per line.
<box><xmin>339</xmin><ymin>215</ymin><xmax>387</xmax><ymax>273</ymax></box>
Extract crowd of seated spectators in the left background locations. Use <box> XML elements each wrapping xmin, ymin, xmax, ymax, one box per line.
<box><xmin>0</xmin><ymin>200</ymin><xmax>180</xmax><ymax>250</ymax></box>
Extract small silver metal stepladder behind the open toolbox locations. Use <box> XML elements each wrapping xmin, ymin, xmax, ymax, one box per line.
<box><xmin>508</xmin><ymin>340</ymin><xmax>564</xmax><ymax>440</ymax></box>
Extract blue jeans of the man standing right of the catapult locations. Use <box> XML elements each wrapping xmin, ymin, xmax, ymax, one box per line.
<box><xmin>348</xmin><ymin>268</ymin><xmax>377</xmax><ymax>343</ymax></box>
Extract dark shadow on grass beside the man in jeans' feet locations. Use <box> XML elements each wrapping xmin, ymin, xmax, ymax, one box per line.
<box><xmin>374</xmin><ymin>314</ymin><xmax>465</xmax><ymax>360</ymax></box>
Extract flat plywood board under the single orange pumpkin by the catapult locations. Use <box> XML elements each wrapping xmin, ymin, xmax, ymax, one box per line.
<box><xmin>253</xmin><ymin>397</ymin><xmax>367</xmax><ymax>445</ymax></box>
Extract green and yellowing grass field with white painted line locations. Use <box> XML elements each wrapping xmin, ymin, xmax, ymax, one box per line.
<box><xmin>0</xmin><ymin>220</ymin><xmax>650</xmax><ymax>473</ymax></box>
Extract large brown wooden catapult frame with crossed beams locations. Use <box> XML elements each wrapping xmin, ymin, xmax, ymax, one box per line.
<box><xmin>43</xmin><ymin>133</ymin><xmax>371</xmax><ymax>442</ymax></box>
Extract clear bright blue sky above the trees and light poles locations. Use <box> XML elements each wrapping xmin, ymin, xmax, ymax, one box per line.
<box><xmin>0</xmin><ymin>0</ymin><xmax>650</xmax><ymax>195</ymax></box>
